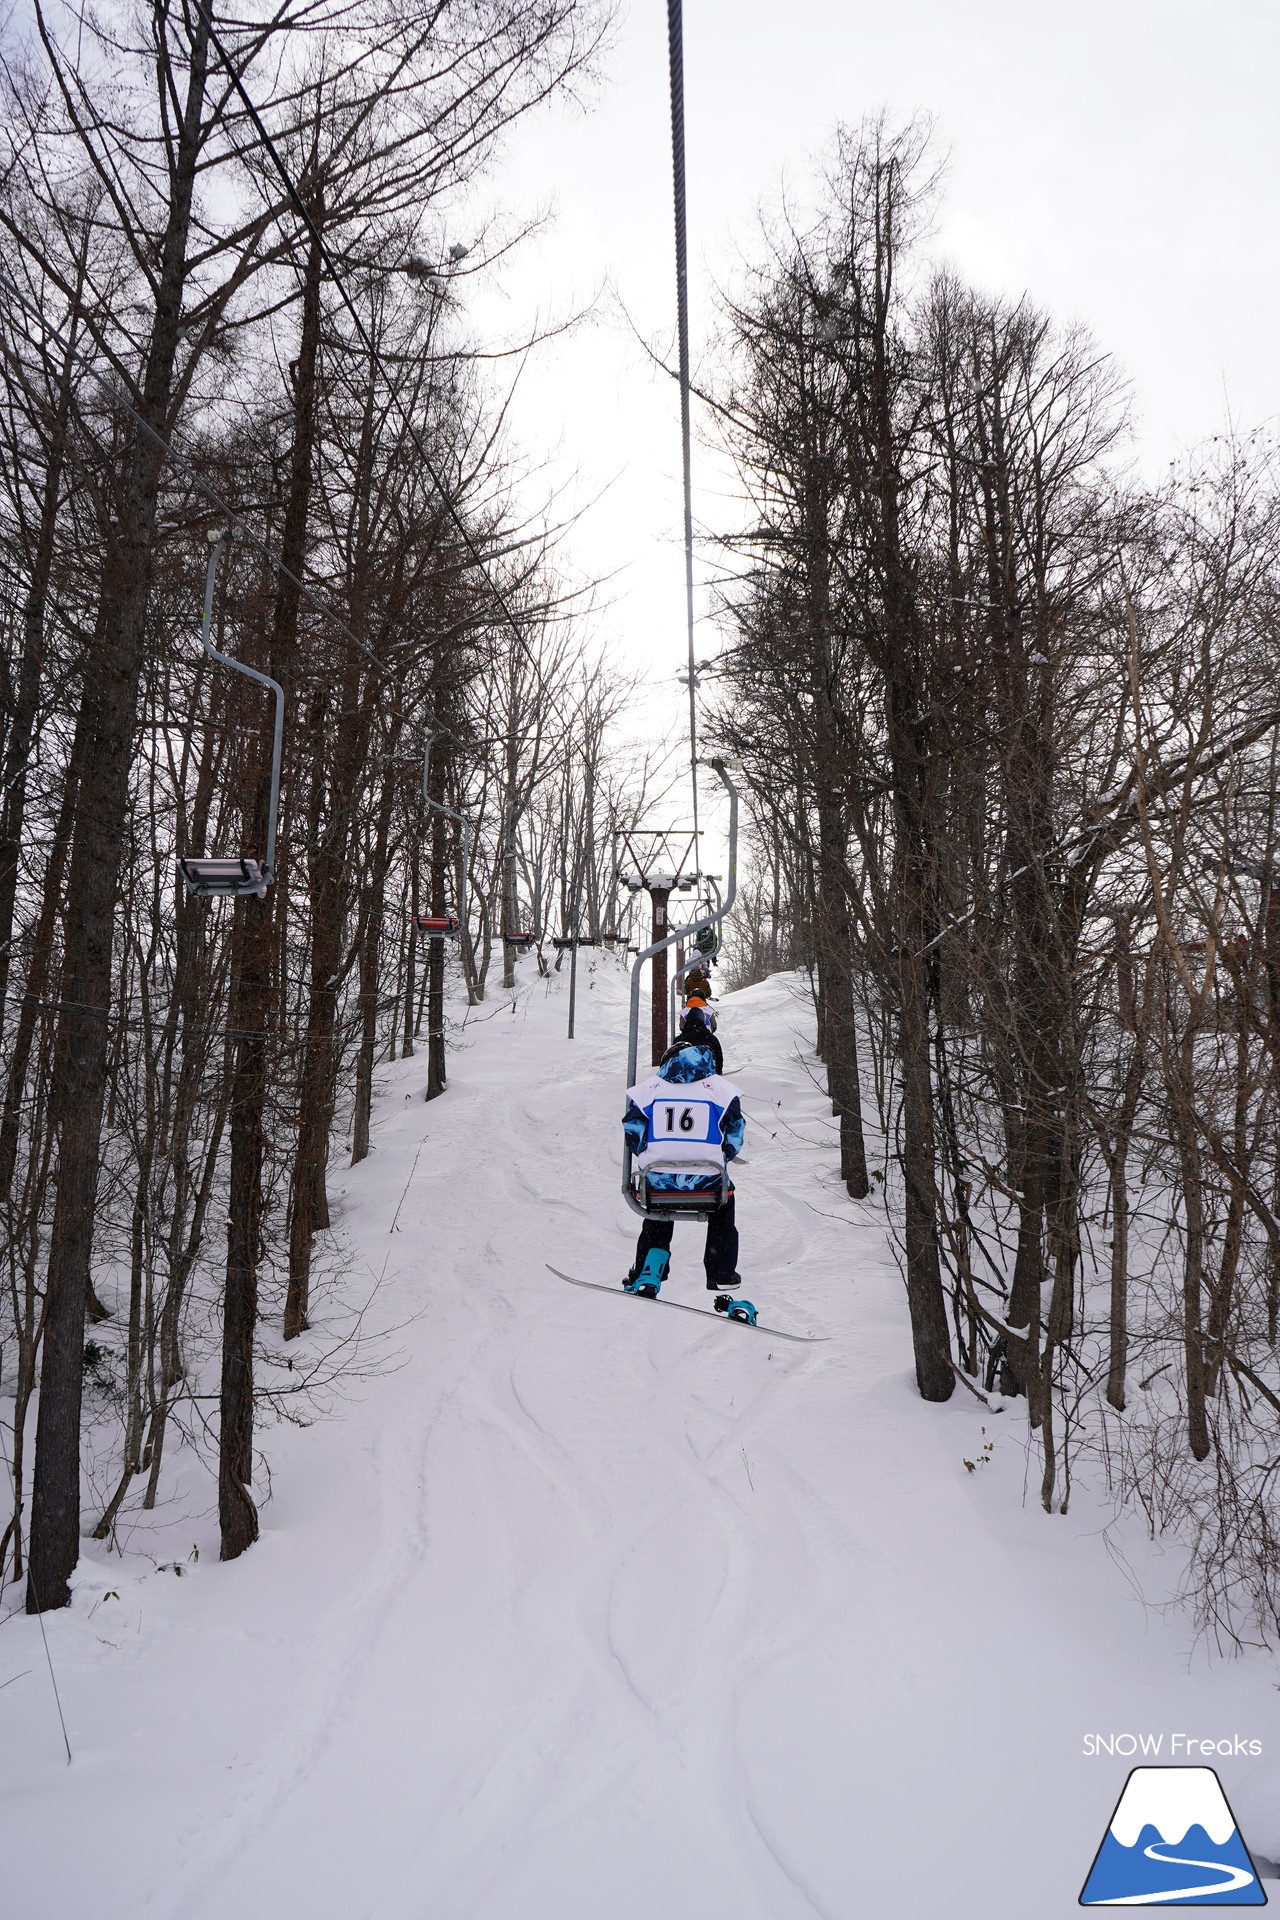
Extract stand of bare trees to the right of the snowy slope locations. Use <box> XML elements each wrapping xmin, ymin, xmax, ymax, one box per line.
<box><xmin>708</xmin><ymin>123</ymin><xmax>1280</xmax><ymax>1640</ymax></box>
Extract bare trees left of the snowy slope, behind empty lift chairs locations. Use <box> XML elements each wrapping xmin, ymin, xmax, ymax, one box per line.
<box><xmin>0</xmin><ymin>0</ymin><xmax>667</xmax><ymax>1611</ymax></box>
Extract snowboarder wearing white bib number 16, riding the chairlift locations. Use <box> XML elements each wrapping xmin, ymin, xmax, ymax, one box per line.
<box><xmin>622</xmin><ymin>1043</ymin><xmax>747</xmax><ymax>1294</ymax></box>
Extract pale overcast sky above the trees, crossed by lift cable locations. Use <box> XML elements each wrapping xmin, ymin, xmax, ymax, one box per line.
<box><xmin>464</xmin><ymin>0</ymin><xmax>1280</xmax><ymax>802</ymax></box>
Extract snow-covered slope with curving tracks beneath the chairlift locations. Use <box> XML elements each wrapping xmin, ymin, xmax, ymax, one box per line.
<box><xmin>0</xmin><ymin>962</ymin><xmax>1280</xmax><ymax>1920</ymax></box>
